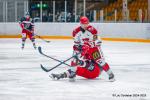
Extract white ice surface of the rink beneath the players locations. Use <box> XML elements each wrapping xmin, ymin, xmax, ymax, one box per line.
<box><xmin>0</xmin><ymin>39</ymin><xmax>150</xmax><ymax>100</ymax></box>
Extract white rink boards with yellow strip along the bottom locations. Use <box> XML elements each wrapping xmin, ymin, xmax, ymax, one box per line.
<box><xmin>0</xmin><ymin>23</ymin><xmax>150</xmax><ymax>42</ymax></box>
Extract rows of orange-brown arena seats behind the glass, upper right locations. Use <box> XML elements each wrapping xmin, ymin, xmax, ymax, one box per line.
<box><xmin>103</xmin><ymin>0</ymin><xmax>148</xmax><ymax>21</ymax></box>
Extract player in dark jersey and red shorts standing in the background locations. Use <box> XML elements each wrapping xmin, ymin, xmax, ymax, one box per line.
<box><xmin>19</xmin><ymin>12</ymin><xmax>36</xmax><ymax>49</ymax></box>
